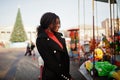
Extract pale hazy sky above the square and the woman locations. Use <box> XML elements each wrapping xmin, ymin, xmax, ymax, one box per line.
<box><xmin>0</xmin><ymin>0</ymin><xmax>119</xmax><ymax>29</ymax></box>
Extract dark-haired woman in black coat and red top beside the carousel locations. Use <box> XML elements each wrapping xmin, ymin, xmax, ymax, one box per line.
<box><xmin>36</xmin><ymin>12</ymin><xmax>72</xmax><ymax>80</ymax></box>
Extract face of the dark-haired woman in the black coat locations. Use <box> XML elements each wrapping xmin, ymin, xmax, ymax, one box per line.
<box><xmin>49</xmin><ymin>18</ymin><xmax>60</xmax><ymax>32</ymax></box>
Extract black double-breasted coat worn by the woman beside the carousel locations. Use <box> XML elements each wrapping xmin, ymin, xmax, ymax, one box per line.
<box><xmin>36</xmin><ymin>28</ymin><xmax>71</xmax><ymax>80</ymax></box>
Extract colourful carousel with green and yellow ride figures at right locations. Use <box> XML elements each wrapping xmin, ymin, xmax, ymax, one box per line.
<box><xmin>79</xmin><ymin>0</ymin><xmax>120</xmax><ymax>80</ymax></box>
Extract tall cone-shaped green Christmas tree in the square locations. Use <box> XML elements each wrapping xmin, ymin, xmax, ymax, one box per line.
<box><xmin>10</xmin><ymin>8</ymin><xmax>27</xmax><ymax>42</ymax></box>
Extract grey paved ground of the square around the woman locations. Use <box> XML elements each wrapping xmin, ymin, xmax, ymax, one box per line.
<box><xmin>0</xmin><ymin>48</ymin><xmax>87</xmax><ymax>80</ymax></box>
